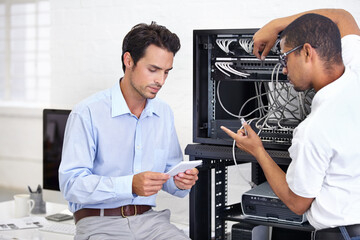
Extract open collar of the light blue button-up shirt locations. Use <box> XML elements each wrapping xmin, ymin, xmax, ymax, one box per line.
<box><xmin>111</xmin><ymin>80</ymin><xmax>159</xmax><ymax>117</ymax></box>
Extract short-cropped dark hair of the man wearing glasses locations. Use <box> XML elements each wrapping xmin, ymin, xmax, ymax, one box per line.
<box><xmin>280</xmin><ymin>13</ymin><xmax>342</xmax><ymax>70</ymax></box>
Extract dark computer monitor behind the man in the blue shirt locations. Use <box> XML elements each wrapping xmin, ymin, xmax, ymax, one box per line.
<box><xmin>43</xmin><ymin>109</ymin><xmax>70</xmax><ymax>191</ymax></box>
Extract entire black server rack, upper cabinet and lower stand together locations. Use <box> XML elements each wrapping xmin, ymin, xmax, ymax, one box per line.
<box><xmin>185</xmin><ymin>29</ymin><xmax>314</xmax><ymax>239</ymax></box>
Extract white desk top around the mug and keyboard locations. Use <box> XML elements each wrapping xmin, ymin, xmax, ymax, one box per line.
<box><xmin>0</xmin><ymin>201</ymin><xmax>74</xmax><ymax>240</ymax></box>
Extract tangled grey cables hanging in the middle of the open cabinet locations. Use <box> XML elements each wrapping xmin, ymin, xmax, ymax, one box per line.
<box><xmin>216</xmin><ymin>63</ymin><xmax>315</xmax><ymax>132</ymax></box>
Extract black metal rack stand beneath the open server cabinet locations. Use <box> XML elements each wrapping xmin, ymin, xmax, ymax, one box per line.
<box><xmin>185</xmin><ymin>144</ymin><xmax>313</xmax><ymax>240</ymax></box>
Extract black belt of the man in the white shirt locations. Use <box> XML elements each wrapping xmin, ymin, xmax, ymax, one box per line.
<box><xmin>315</xmin><ymin>224</ymin><xmax>360</xmax><ymax>240</ymax></box>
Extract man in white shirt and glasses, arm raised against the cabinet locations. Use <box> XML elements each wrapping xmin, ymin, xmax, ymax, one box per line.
<box><xmin>222</xmin><ymin>9</ymin><xmax>360</xmax><ymax>240</ymax></box>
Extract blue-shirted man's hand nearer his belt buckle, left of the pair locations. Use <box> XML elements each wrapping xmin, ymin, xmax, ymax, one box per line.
<box><xmin>132</xmin><ymin>172</ymin><xmax>170</xmax><ymax>197</ymax></box>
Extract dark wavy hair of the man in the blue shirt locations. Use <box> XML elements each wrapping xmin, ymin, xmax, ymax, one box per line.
<box><xmin>121</xmin><ymin>22</ymin><xmax>180</xmax><ymax>72</ymax></box>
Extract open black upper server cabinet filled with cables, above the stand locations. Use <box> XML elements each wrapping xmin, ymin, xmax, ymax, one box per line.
<box><xmin>193</xmin><ymin>29</ymin><xmax>313</xmax><ymax>150</ymax></box>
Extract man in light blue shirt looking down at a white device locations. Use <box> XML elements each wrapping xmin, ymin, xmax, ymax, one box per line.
<box><xmin>59</xmin><ymin>22</ymin><xmax>198</xmax><ymax>239</ymax></box>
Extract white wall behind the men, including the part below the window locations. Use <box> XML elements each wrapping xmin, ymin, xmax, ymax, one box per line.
<box><xmin>0</xmin><ymin>0</ymin><xmax>360</xmax><ymax>229</ymax></box>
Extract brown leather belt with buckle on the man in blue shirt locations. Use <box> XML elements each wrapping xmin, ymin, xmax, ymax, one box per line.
<box><xmin>74</xmin><ymin>205</ymin><xmax>151</xmax><ymax>223</ymax></box>
